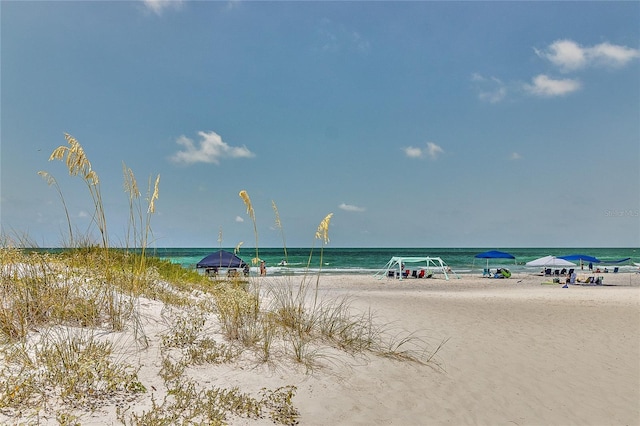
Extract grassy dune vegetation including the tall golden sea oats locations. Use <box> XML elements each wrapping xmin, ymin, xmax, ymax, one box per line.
<box><xmin>0</xmin><ymin>134</ymin><xmax>438</xmax><ymax>425</ymax></box>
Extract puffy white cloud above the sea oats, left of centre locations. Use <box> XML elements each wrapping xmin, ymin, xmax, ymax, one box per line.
<box><xmin>171</xmin><ymin>132</ymin><xmax>255</xmax><ymax>164</ymax></box>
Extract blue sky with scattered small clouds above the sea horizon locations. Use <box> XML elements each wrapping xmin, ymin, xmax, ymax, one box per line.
<box><xmin>0</xmin><ymin>0</ymin><xmax>640</xmax><ymax>249</ymax></box>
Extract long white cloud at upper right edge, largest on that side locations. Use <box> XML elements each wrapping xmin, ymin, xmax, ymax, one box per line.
<box><xmin>534</xmin><ymin>40</ymin><xmax>640</xmax><ymax>72</ymax></box>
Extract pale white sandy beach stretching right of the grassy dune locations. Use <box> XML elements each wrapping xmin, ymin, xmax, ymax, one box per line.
<box><xmin>0</xmin><ymin>273</ymin><xmax>640</xmax><ymax>426</ymax></box>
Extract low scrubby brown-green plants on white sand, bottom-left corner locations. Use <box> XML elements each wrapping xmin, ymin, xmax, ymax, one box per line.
<box><xmin>0</xmin><ymin>327</ymin><xmax>146</xmax><ymax>415</ymax></box>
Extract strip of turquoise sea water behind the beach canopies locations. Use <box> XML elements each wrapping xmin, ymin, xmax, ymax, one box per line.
<box><xmin>155</xmin><ymin>248</ymin><xmax>640</xmax><ymax>275</ymax></box>
